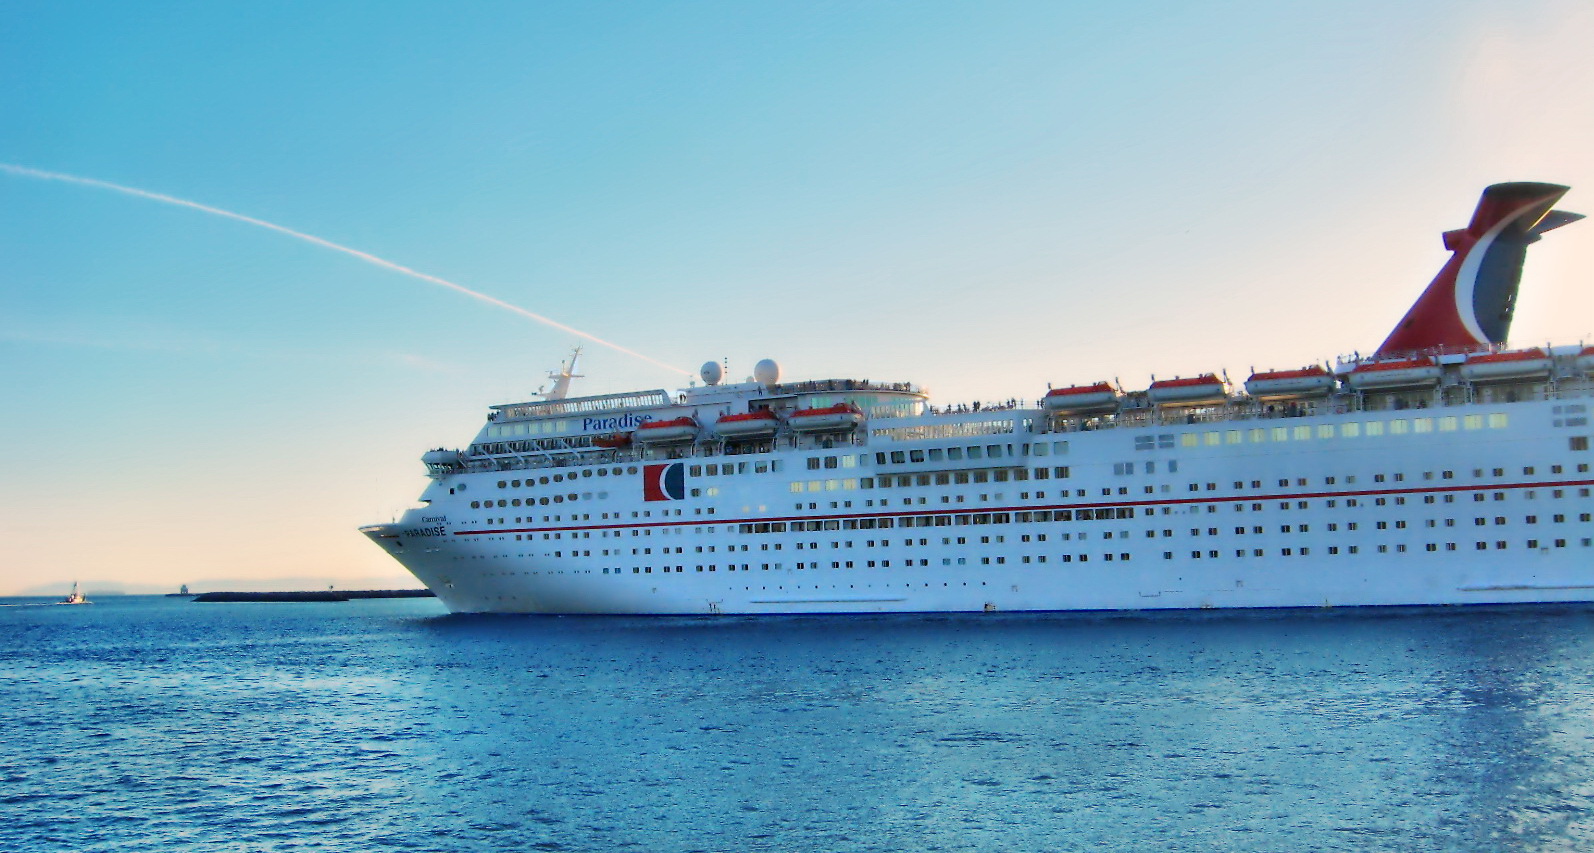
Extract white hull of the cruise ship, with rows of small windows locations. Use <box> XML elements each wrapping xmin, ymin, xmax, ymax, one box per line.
<box><xmin>365</xmin><ymin>393</ymin><xmax>1594</xmax><ymax>614</ymax></box>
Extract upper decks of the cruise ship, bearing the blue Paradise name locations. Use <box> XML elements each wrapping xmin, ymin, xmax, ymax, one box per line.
<box><xmin>426</xmin><ymin>346</ymin><xmax>1594</xmax><ymax>477</ymax></box>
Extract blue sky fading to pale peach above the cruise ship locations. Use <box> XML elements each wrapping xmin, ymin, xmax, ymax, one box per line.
<box><xmin>0</xmin><ymin>0</ymin><xmax>1594</xmax><ymax>596</ymax></box>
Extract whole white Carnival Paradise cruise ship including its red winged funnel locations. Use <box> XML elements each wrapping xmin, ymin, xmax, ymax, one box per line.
<box><xmin>362</xmin><ymin>183</ymin><xmax>1594</xmax><ymax>614</ymax></box>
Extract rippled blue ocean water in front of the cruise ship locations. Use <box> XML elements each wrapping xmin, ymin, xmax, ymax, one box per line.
<box><xmin>0</xmin><ymin>598</ymin><xmax>1594</xmax><ymax>853</ymax></box>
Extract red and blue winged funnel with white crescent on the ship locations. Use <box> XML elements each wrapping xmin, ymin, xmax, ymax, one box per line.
<box><xmin>1377</xmin><ymin>182</ymin><xmax>1583</xmax><ymax>356</ymax></box>
